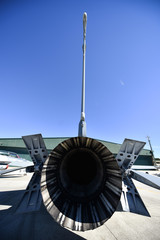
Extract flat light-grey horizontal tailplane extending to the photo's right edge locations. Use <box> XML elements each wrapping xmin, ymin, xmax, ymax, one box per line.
<box><xmin>131</xmin><ymin>170</ymin><xmax>160</xmax><ymax>189</ymax></box>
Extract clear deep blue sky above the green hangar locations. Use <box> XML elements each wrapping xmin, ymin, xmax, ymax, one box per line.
<box><xmin>0</xmin><ymin>0</ymin><xmax>160</xmax><ymax>157</ymax></box>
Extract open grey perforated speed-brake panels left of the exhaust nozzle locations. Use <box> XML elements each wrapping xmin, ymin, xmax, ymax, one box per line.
<box><xmin>16</xmin><ymin>134</ymin><xmax>48</xmax><ymax>213</ymax></box>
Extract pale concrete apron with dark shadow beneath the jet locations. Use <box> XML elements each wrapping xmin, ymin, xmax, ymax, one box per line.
<box><xmin>0</xmin><ymin>171</ymin><xmax>160</xmax><ymax>240</ymax></box>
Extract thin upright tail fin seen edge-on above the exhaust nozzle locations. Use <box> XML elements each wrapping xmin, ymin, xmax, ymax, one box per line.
<box><xmin>78</xmin><ymin>12</ymin><xmax>87</xmax><ymax>137</ymax></box>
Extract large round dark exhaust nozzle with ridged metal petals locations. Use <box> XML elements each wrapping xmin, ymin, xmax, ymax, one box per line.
<box><xmin>41</xmin><ymin>137</ymin><xmax>122</xmax><ymax>231</ymax></box>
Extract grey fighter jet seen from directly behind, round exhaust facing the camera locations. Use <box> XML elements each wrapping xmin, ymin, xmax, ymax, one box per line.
<box><xmin>13</xmin><ymin>13</ymin><xmax>160</xmax><ymax>231</ymax></box>
